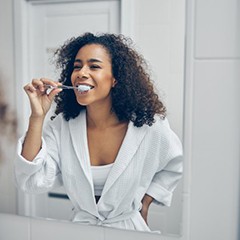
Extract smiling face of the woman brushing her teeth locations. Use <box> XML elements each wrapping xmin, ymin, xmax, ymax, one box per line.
<box><xmin>71</xmin><ymin>44</ymin><xmax>116</xmax><ymax>106</ymax></box>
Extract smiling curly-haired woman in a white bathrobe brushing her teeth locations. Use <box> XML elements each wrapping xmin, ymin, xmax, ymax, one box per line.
<box><xmin>16</xmin><ymin>33</ymin><xmax>182</xmax><ymax>231</ymax></box>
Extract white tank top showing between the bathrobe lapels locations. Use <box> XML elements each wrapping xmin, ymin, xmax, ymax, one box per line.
<box><xmin>91</xmin><ymin>163</ymin><xmax>113</xmax><ymax>196</ymax></box>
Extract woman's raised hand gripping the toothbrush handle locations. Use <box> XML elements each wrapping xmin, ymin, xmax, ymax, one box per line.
<box><xmin>24</xmin><ymin>78</ymin><xmax>62</xmax><ymax>118</ymax></box>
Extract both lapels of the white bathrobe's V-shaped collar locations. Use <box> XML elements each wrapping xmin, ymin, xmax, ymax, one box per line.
<box><xmin>69</xmin><ymin>110</ymin><xmax>147</xmax><ymax>201</ymax></box>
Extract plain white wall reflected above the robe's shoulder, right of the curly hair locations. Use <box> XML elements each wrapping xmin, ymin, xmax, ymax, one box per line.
<box><xmin>134</xmin><ymin>0</ymin><xmax>185</xmax><ymax>138</ymax></box>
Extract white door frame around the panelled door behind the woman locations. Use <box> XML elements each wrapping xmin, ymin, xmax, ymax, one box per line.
<box><xmin>13</xmin><ymin>0</ymin><xmax>136</xmax><ymax>216</ymax></box>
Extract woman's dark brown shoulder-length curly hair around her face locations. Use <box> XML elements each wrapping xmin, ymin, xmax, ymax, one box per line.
<box><xmin>52</xmin><ymin>33</ymin><xmax>166</xmax><ymax>127</ymax></box>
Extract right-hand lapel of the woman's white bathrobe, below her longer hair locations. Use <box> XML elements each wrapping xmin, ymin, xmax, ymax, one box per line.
<box><xmin>100</xmin><ymin>122</ymin><xmax>147</xmax><ymax>199</ymax></box>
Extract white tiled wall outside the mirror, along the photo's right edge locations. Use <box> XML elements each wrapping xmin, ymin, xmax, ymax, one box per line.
<box><xmin>186</xmin><ymin>0</ymin><xmax>240</xmax><ymax>240</ymax></box>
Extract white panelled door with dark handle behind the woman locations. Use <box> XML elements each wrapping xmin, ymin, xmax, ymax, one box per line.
<box><xmin>26</xmin><ymin>0</ymin><xmax>120</xmax><ymax>219</ymax></box>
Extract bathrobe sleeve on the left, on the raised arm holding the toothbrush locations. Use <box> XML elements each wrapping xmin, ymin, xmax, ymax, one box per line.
<box><xmin>15</xmin><ymin>117</ymin><xmax>62</xmax><ymax>193</ymax></box>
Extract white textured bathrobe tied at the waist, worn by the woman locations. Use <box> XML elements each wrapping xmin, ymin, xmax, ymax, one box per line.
<box><xmin>15</xmin><ymin>111</ymin><xmax>182</xmax><ymax>231</ymax></box>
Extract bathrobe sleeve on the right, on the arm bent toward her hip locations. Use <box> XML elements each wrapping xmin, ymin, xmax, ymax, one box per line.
<box><xmin>146</xmin><ymin>120</ymin><xmax>183</xmax><ymax>207</ymax></box>
